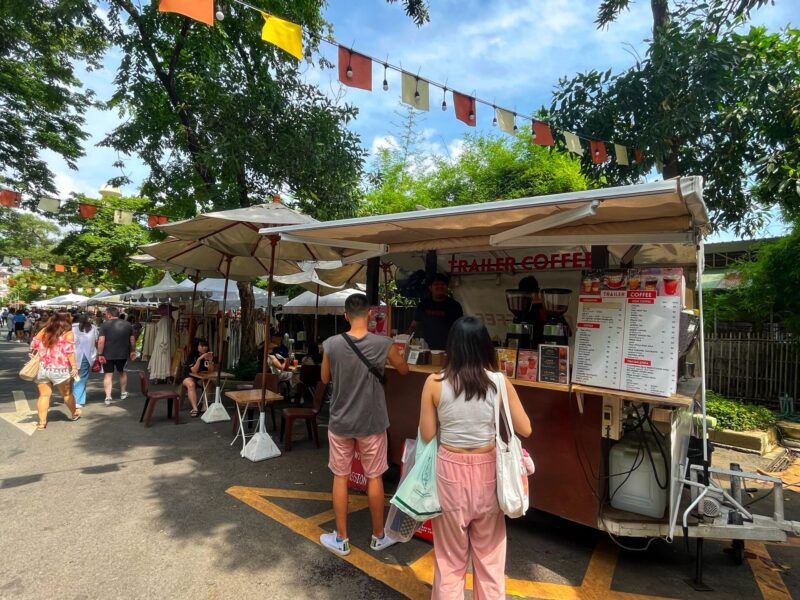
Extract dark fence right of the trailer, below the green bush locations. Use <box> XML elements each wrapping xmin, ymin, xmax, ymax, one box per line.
<box><xmin>705</xmin><ymin>332</ymin><xmax>800</xmax><ymax>407</ymax></box>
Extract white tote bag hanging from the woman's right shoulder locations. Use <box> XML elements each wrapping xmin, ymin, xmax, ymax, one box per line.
<box><xmin>494</xmin><ymin>373</ymin><xmax>530</xmax><ymax>519</ymax></box>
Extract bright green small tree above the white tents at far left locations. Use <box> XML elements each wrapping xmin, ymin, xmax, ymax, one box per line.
<box><xmin>55</xmin><ymin>194</ymin><xmax>159</xmax><ymax>289</ymax></box>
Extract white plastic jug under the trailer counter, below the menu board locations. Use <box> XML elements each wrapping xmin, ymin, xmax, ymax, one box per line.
<box><xmin>608</xmin><ymin>433</ymin><xmax>669</xmax><ymax>519</ymax></box>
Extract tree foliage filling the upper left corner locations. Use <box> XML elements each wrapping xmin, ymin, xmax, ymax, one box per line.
<box><xmin>0</xmin><ymin>0</ymin><xmax>106</xmax><ymax>200</ymax></box>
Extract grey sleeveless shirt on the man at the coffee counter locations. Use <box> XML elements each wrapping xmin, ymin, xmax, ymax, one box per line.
<box><xmin>322</xmin><ymin>333</ymin><xmax>392</xmax><ymax>437</ymax></box>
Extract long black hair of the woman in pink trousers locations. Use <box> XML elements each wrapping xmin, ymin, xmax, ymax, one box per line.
<box><xmin>439</xmin><ymin>317</ymin><xmax>497</xmax><ymax>400</ymax></box>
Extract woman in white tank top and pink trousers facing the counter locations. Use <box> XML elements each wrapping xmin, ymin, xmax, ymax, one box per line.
<box><xmin>419</xmin><ymin>317</ymin><xmax>532</xmax><ymax>600</ymax></box>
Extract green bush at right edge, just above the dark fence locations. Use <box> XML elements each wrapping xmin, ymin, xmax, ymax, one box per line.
<box><xmin>704</xmin><ymin>227</ymin><xmax>800</xmax><ymax>335</ymax></box>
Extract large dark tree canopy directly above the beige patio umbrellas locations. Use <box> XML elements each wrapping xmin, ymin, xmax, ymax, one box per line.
<box><xmin>103</xmin><ymin>0</ymin><xmax>363</xmax><ymax>219</ymax></box>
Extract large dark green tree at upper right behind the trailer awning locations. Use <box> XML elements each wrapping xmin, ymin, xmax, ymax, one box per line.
<box><xmin>550</xmin><ymin>0</ymin><xmax>800</xmax><ymax>234</ymax></box>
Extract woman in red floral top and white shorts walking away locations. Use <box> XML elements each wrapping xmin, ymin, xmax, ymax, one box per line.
<box><xmin>31</xmin><ymin>312</ymin><xmax>81</xmax><ymax>429</ymax></box>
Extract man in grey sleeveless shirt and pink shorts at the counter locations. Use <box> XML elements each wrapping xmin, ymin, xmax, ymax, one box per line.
<box><xmin>319</xmin><ymin>294</ymin><xmax>408</xmax><ymax>556</ymax></box>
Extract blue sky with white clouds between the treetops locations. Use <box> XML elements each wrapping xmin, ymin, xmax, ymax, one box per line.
<box><xmin>46</xmin><ymin>0</ymin><xmax>796</xmax><ymax>241</ymax></box>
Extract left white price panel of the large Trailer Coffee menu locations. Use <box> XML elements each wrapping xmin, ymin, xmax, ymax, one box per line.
<box><xmin>572</xmin><ymin>292</ymin><xmax>626</xmax><ymax>389</ymax></box>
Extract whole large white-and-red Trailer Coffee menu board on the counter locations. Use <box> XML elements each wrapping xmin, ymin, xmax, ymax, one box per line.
<box><xmin>572</xmin><ymin>269</ymin><xmax>684</xmax><ymax>396</ymax></box>
